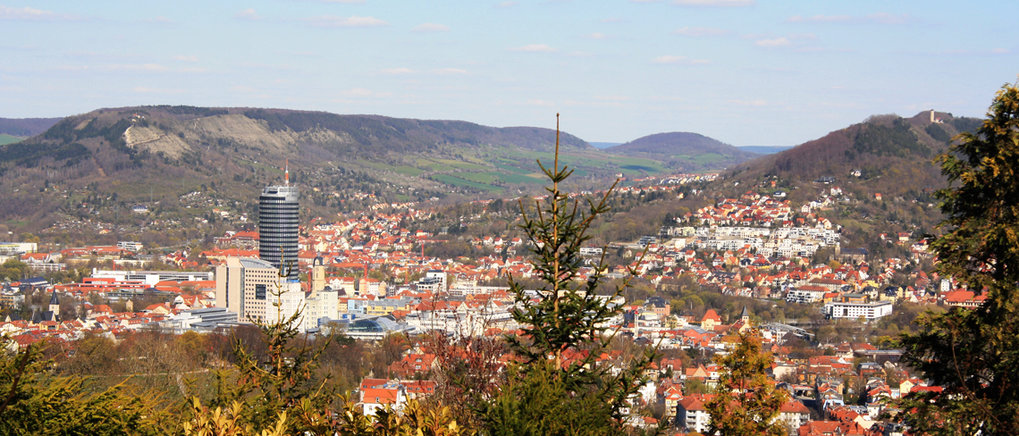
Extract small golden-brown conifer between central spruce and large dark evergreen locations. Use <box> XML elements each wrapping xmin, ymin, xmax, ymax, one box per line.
<box><xmin>704</xmin><ymin>329</ymin><xmax>788</xmax><ymax>436</ymax></box>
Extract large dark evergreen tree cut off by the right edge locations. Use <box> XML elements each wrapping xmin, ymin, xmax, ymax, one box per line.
<box><xmin>900</xmin><ymin>80</ymin><xmax>1019</xmax><ymax>435</ymax></box>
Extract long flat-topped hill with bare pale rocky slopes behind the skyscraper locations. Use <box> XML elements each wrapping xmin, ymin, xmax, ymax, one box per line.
<box><xmin>0</xmin><ymin>106</ymin><xmax>729</xmax><ymax>241</ymax></box>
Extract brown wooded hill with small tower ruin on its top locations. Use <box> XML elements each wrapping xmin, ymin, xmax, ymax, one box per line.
<box><xmin>715</xmin><ymin>111</ymin><xmax>980</xmax><ymax>250</ymax></box>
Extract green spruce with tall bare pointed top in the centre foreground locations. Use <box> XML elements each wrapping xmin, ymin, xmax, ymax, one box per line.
<box><xmin>481</xmin><ymin>115</ymin><xmax>653</xmax><ymax>435</ymax></box>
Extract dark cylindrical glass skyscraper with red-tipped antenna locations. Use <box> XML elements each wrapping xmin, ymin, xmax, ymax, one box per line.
<box><xmin>258</xmin><ymin>163</ymin><xmax>299</xmax><ymax>280</ymax></box>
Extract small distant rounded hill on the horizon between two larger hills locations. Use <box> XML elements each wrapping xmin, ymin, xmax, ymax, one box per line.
<box><xmin>605</xmin><ymin>131</ymin><xmax>758</xmax><ymax>171</ymax></box>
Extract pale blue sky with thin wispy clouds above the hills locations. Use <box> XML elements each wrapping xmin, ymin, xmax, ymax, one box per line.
<box><xmin>0</xmin><ymin>0</ymin><xmax>1019</xmax><ymax>146</ymax></box>
